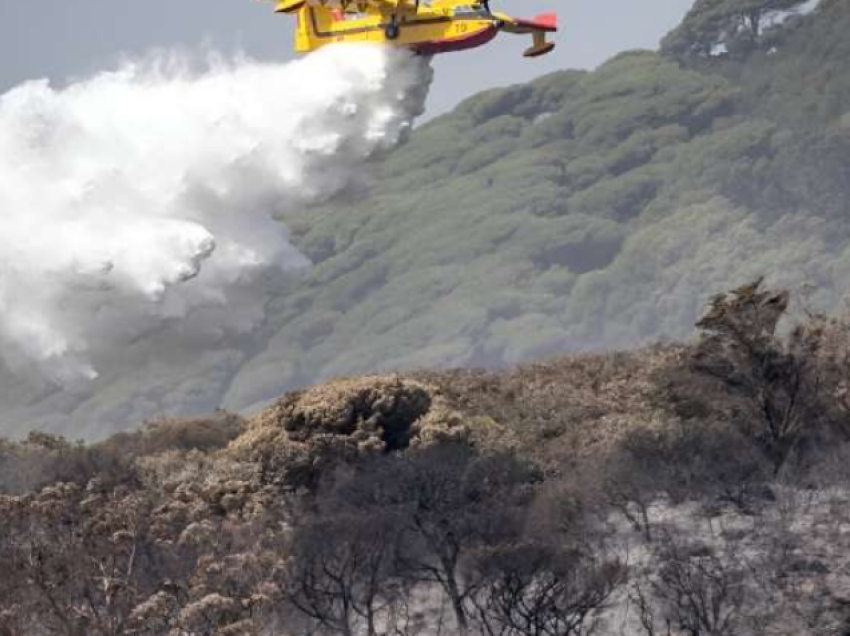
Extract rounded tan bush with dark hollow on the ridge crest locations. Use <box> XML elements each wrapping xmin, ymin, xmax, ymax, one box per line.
<box><xmin>228</xmin><ymin>376</ymin><xmax>512</xmax><ymax>494</ymax></box>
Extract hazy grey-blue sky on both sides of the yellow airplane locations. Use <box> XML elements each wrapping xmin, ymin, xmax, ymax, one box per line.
<box><xmin>0</xmin><ymin>0</ymin><xmax>693</xmax><ymax>114</ymax></box>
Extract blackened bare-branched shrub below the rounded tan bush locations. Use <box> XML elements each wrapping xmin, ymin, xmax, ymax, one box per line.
<box><xmin>346</xmin><ymin>443</ymin><xmax>540</xmax><ymax>631</ymax></box>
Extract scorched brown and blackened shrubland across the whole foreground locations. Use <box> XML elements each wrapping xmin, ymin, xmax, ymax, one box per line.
<box><xmin>0</xmin><ymin>281</ymin><xmax>850</xmax><ymax>636</ymax></box>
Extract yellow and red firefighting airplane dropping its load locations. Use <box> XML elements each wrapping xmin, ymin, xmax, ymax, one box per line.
<box><xmin>266</xmin><ymin>0</ymin><xmax>558</xmax><ymax>57</ymax></box>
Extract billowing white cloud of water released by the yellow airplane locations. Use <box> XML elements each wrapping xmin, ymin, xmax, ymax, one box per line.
<box><xmin>0</xmin><ymin>46</ymin><xmax>430</xmax><ymax>383</ymax></box>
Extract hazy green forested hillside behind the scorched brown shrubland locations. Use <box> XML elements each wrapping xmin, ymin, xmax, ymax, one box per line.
<box><xmin>0</xmin><ymin>0</ymin><xmax>850</xmax><ymax>436</ymax></box>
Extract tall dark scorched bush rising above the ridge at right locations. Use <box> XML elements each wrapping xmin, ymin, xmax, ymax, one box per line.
<box><xmin>665</xmin><ymin>280</ymin><xmax>848</xmax><ymax>475</ymax></box>
